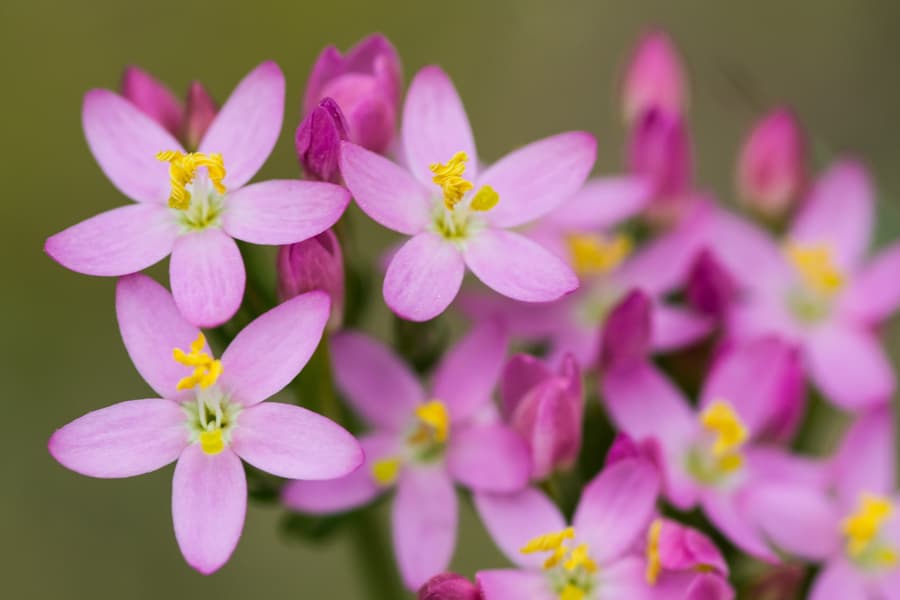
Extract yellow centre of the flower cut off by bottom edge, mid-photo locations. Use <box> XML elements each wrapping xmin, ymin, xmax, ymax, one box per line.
<box><xmin>519</xmin><ymin>527</ymin><xmax>598</xmax><ymax>600</ymax></box>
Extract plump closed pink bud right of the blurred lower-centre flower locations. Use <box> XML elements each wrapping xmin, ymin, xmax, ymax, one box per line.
<box><xmin>500</xmin><ymin>354</ymin><xmax>584</xmax><ymax>480</ymax></box>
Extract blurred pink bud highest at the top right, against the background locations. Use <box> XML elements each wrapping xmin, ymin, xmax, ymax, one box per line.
<box><xmin>622</xmin><ymin>31</ymin><xmax>687</xmax><ymax>123</ymax></box>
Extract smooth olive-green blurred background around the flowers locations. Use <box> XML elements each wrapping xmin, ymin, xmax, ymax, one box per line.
<box><xmin>0</xmin><ymin>0</ymin><xmax>900</xmax><ymax>600</ymax></box>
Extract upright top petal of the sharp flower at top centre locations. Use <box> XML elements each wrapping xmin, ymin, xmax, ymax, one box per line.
<box><xmin>401</xmin><ymin>66</ymin><xmax>478</xmax><ymax>190</ymax></box>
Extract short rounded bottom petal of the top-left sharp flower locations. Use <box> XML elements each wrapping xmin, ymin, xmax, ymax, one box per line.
<box><xmin>169</xmin><ymin>229</ymin><xmax>247</xmax><ymax>327</ymax></box>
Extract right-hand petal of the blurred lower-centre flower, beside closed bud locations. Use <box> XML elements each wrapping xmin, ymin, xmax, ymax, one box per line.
<box><xmin>447</xmin><ymin>424</ymin><xmax>531</xmax><ymax>494</ymax></box>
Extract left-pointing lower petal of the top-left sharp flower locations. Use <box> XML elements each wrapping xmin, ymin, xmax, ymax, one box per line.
<box><xmin>44</xmin><ymin>204</ymin><xmax>178</xmax><ymax>276</ymax></box>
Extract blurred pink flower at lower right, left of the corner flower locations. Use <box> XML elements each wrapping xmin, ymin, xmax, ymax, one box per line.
<box><xmin>602</xmin><ymin>339</ymin><xmax>824</xmax><ymax>562</ymax></box>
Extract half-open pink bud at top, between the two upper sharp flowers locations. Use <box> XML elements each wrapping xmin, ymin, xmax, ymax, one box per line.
<box><xmin>303</xmin><ymin>34</ymin><xmax>403</xmax><ymax>154</ymax></box>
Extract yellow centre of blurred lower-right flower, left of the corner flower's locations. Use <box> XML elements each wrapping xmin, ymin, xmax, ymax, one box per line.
<box><xmin>687</xmin><ymin>400</ymin><xmax>749</xmax><ymax>484</ymax></box>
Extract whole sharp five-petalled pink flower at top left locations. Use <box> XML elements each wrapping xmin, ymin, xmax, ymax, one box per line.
<box><xmin>44</xmin><ymin>62</ymin><xmax>349</xmax><ymax>327</ymax></box>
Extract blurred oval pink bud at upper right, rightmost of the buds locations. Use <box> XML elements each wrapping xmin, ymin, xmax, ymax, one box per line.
<box><xmin>737</xmin><ymin>108</ymin><xmax>807</xmax><ymax>219</ymax></box>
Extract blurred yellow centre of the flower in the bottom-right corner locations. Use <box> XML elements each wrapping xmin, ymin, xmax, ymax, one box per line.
<box><xmin>841</xmin><ymin>492</ymin><xmax>898</xmax><ymax>569</ymax></box>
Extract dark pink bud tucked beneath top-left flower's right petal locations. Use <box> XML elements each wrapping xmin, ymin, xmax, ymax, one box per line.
<box><xmin>277</xmin><ymin>229</ymin><xmax>344</xmax><ymax>331</ymax></box>
